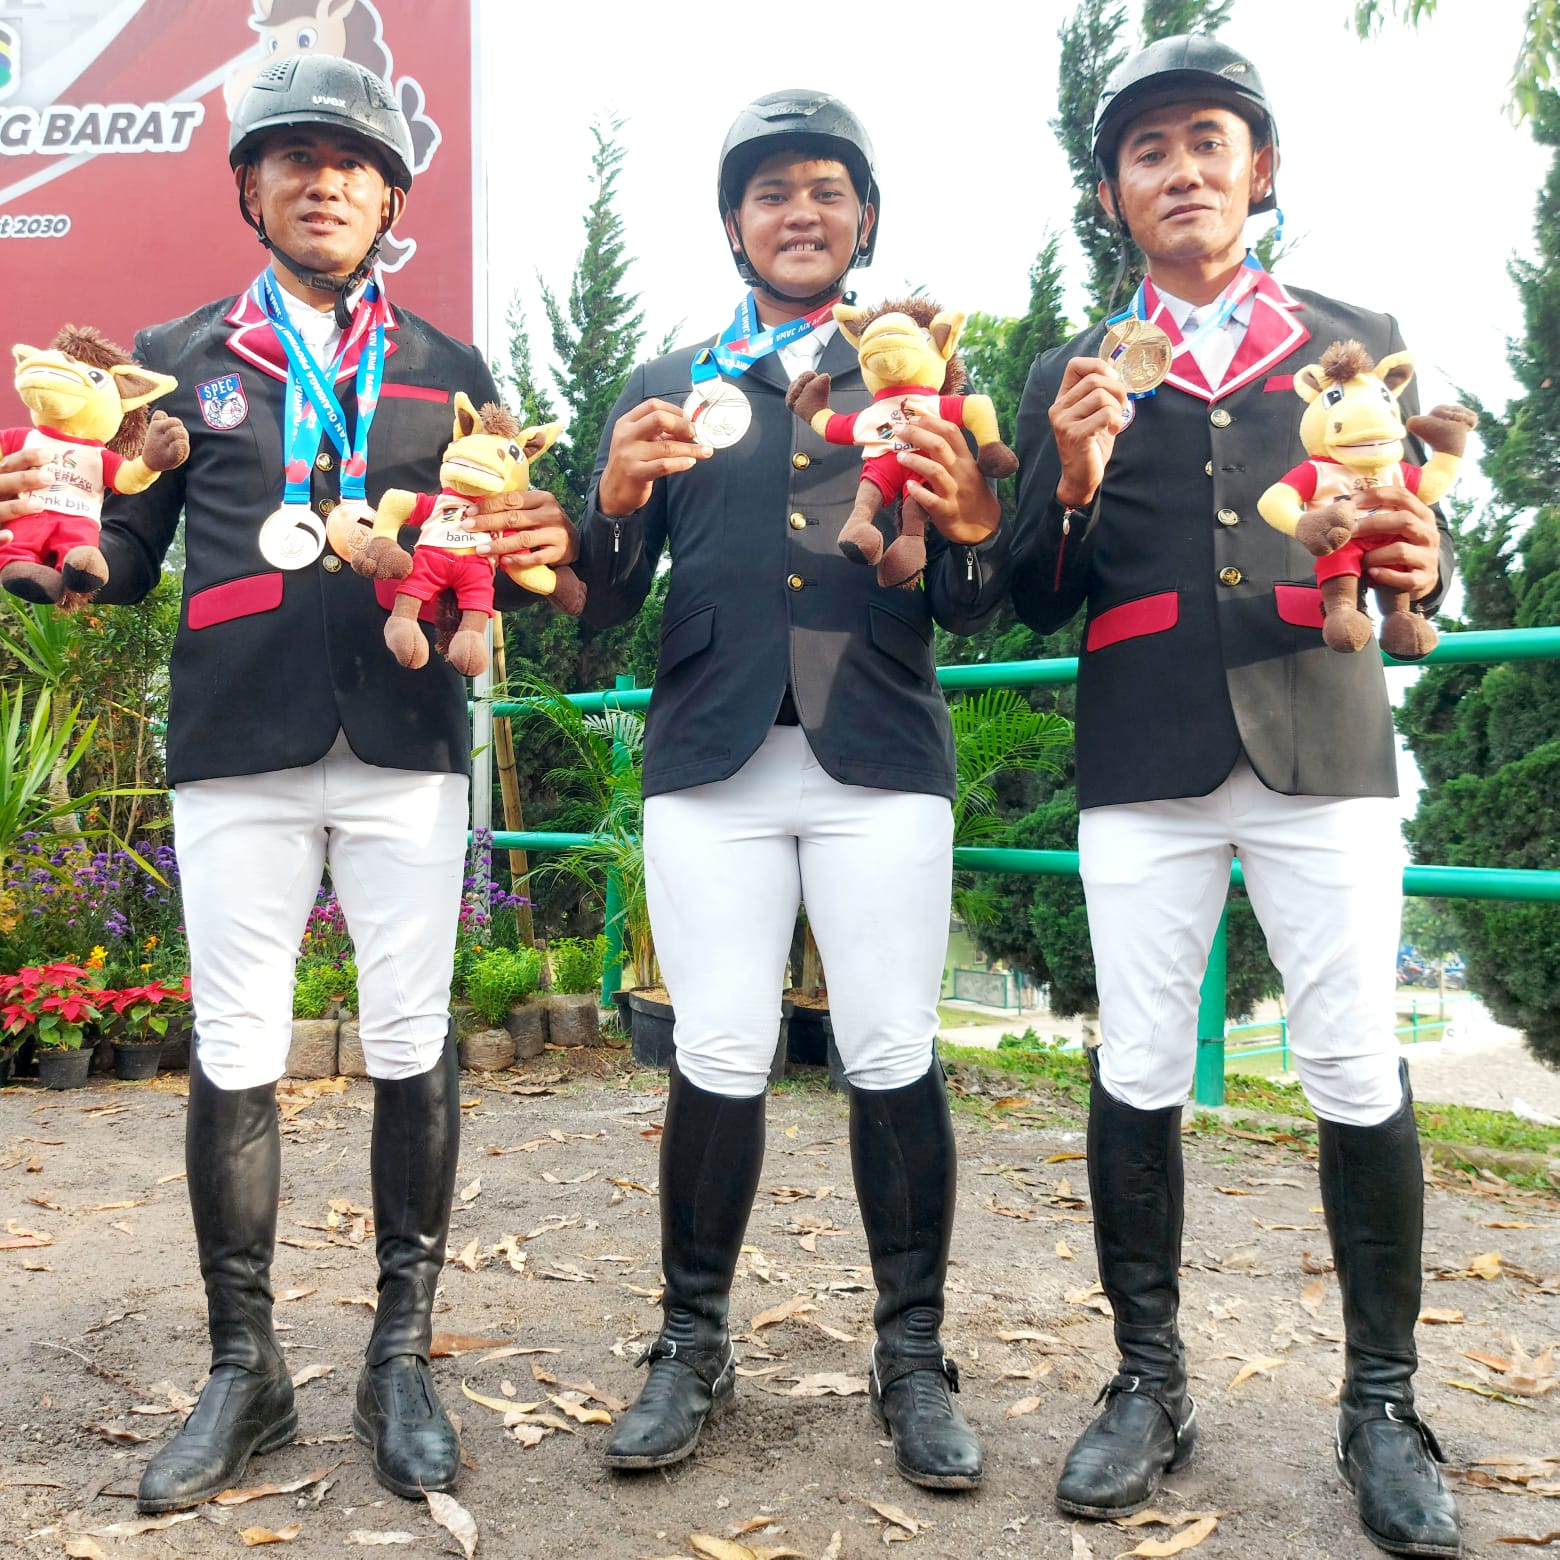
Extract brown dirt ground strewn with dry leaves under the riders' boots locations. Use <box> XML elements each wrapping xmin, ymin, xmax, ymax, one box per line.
<box><xmin>0</xmin><ymin>1051</ymin><xmax>1560</xmax><ymax>1560</ymax></box>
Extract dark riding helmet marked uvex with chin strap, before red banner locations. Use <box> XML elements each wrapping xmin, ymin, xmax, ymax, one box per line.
<box><xmin>228</xmin><ymin>55</ymin><xmax>412</xmax><ymax>329</ymax></box>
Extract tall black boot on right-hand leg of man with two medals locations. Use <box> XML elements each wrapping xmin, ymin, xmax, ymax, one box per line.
<box><xmin>353</xmin><ymin>1044</ymin><xmax>460</xmax><ymax>1499</ymax></box>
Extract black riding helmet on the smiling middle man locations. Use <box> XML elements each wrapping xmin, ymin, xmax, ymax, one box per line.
<box><xmin>716</xmin><ymin>87</ymin><xmax>883</xmax><ymax>304</ymax></box>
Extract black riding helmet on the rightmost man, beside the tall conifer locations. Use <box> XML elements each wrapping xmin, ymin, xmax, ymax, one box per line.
<box><xmin>1094</xmin><ymin>33</ymin><xmax>1278</xmax><ymax>212</ymax></box>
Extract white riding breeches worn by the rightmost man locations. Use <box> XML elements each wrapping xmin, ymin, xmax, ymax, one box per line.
<box><xmin>1078</xmin><ymin>758</ymin><xmax>1406</xmax><ymax>1126</ymax></box>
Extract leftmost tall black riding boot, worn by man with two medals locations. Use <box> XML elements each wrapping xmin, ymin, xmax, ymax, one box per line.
<box><xmin>136</xmin><ymin>1058</ymin><xmax>298</xmax><ymax>1512</ymax></box>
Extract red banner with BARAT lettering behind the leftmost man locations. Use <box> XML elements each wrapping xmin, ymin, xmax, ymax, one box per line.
<box><xmin>0</xmin><ymin>0</ymin><xmax>476</xmax><ymax>426</ymax></box>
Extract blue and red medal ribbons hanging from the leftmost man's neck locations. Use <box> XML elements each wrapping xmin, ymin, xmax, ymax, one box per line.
<box><xmin>251</xmin><ymin>270</ymin><xmax>385</xmax><ymax>509</ymax></box>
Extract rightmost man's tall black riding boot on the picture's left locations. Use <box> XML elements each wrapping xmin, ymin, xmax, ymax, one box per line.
<box><xmin>1056</xmin><ymin>1053</ymin><xmax>1197</xmax><ymax>1518</ymax></box>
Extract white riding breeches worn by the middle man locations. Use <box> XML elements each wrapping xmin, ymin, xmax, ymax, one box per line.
<box><xmin>644</xmin><ymin>725</ymin><xmax>953</xmax><ymax>1098</ymax></box>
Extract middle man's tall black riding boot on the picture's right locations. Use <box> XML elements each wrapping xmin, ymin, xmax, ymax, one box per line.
<box><xmin>850</xmin><ymin>1061</ymin><xmax>984</xmax><ymax>1490</ymax></box>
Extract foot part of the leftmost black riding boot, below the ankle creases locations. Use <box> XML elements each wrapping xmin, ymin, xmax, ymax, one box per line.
<box><xmin>136</xmin><ymin>1365</ymin><xmax>298</xmax><ymax>1516</ymax></box>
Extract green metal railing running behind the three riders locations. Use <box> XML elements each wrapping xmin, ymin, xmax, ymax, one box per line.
<box><xmin>493</xmin><ymin>627</ymin><xmax>1560</xmax><ymax>1104</ymax></box>
